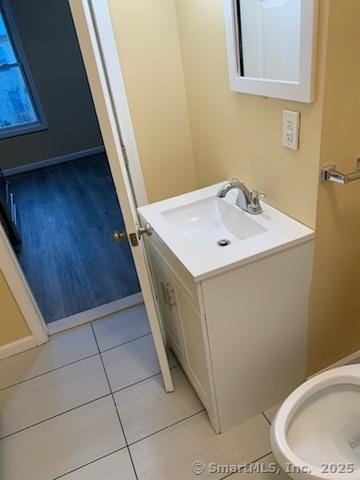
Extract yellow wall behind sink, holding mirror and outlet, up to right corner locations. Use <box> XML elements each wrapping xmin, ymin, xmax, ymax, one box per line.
<box><xmin>175</xmin><ymin>0</ymin><xmax>327</xmax><ymax>226</ymax></box>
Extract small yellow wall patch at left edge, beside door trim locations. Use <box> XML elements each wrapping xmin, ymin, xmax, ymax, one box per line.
<box><xmin>0</xmin><ymin>270</ymin><xmax>30</xmax><ymax>346</ymax></box>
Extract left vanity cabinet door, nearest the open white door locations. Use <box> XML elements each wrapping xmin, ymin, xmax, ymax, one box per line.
<box><xmin>148</xmin><ymin>243</ymin><xmax>184</xmax><ymax>359</ymax></box>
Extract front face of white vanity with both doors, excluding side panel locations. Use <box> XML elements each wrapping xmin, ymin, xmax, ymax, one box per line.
<box><xmin>147</xmin><ymin>233</ymin><xmax>219</xmax><ymax>432</ymax></box>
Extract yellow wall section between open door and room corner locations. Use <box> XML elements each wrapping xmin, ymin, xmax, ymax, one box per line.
<box><xmin>109</xmin><ymin>0</ymin><xmax>196</xmax><ymax>201</ymax></box>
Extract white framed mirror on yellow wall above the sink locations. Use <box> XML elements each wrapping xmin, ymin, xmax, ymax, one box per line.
<box><xmin>225</xmin><ymin>0</ymin><xmax>319</xmax><ymax>103</ymax></box>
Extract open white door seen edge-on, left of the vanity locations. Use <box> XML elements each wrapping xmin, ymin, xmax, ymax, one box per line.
<box><xmin>69</xmin><ymin>0</ymin><xmax>174</xmax><ymax>392</ymax></box>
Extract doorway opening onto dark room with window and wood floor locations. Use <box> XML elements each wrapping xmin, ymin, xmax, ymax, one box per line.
<box><xmin>0</xmin><ymin>0</ymin><xmax>142</xmax><ymax>331</ymax></box>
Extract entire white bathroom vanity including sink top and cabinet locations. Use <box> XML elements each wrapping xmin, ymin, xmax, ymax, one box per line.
<box><xmin>139</xmin><ymin>184</ymin><xmax>314</xmax><ymax>432</ymax></box>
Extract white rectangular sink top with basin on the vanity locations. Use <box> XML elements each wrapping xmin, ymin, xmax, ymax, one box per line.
<box><xmin>138</xmin><ymin>183</ymin><xmax>315</xmax><ymax>280</ymax></box>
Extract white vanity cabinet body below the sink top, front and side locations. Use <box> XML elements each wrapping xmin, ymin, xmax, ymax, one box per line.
<box><xmin>147</xmin><ymin>233</ymin><xmax>313</xmax><ymax>433</ymax></box>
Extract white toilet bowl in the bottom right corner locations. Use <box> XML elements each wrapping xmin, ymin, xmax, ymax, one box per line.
<box><xmin>270</xmin><ymin>365</ymin><xmax>360</xmax><ymax>480</ymax></box>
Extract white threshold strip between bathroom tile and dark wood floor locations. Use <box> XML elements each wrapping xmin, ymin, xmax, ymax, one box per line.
<box><xmin>48</xmin><ymin>292</ymin><xmax>143</xmax><ymax>335</ymax></box>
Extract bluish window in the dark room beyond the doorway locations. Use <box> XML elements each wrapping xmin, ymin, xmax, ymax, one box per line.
<box><xmin>0</xmin><ymin>0</ymin><xmax>45</xmax><ymax>138</ymax></box>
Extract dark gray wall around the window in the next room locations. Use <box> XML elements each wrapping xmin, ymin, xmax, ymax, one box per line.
<box><xmin>0</xmin><ymin>0</ymin><xmax>102</xmax><ymax>168</ymax></box>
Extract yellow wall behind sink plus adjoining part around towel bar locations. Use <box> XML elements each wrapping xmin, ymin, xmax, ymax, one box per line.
<box><xmin>175</xmin><ymin>0</ymin><xmax>360</xmax><ymax>373</ymax></box>
